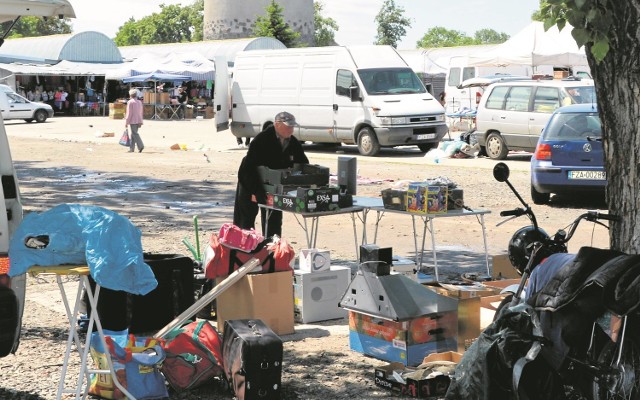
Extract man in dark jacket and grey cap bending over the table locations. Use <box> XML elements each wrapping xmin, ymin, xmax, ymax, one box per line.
<box><xmin>233</xmin><ymin>112</ymin><xmax>309</xmax><ymax>237</ymax></box>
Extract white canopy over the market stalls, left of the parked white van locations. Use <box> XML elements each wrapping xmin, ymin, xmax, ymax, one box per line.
<box><xmin>105</xmin><ymin>52</ymin><xmax>215</xmax><ymax>81</ymax></box>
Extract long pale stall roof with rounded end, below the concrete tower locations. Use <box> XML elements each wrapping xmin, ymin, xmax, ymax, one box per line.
<box><xmin>120</xmin><ymin>37</ymin><xmax>286</xmax><ymax>65</ymax></box>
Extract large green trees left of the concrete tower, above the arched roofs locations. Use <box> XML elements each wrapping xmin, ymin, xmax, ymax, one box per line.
<box><xmin>114</xmin><ymin>0</ymin><xmax>204</xmax><ymax>46</ymax></box>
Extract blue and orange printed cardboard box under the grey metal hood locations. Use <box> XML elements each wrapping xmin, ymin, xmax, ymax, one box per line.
<box><xmin>349</xmin><ymin>311</ymin><xmax>458</xmax><ymax>366</ymax></box>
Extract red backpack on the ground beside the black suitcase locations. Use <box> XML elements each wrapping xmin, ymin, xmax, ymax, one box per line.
<box><xmin>162</xmin><ymin>320</ymin><xmax>224</xmax><ymax>392</ymax></box>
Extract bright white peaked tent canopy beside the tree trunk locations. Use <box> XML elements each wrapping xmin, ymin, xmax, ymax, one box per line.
<box><xmin>469</xmin><ymin>22</ymin><xmax>588</xmax><ymax>67</ymax></box>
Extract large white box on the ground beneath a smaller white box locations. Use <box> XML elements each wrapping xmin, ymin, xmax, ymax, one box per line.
<box><xmin>293</xmin><ymin>265</ymin><xmax>351</xmax><ymax>324</ymax></box>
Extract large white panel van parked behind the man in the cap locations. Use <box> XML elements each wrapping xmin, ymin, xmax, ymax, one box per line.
<box><xmin>231</xmin><ymin>46</ymin><xmax>447</xmax><ymax>156</ymax></box>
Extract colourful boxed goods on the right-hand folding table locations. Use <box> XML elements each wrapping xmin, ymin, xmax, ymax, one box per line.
<box><xmin>382</xmin><ymin>177</ymin><xmax>464</xmax><ymax>214</ymax></box>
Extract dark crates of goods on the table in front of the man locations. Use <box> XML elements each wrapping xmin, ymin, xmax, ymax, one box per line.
<box><xmin>258</xmin><ymin>164</ymin><xmax>353</xmax><ymax>212</ymax></box>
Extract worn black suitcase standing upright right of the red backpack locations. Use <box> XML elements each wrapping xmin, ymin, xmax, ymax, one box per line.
<box><xmin>222</xmin><ymin>319</ymin><xmax>282</xmax><ymax>400</ymax></box>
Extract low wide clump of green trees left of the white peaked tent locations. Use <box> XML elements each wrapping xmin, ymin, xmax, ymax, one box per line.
<box><xmin>416</xmin><ymin>26</ymin><xmax>509</xmax><ymax>48</ymax></box>
